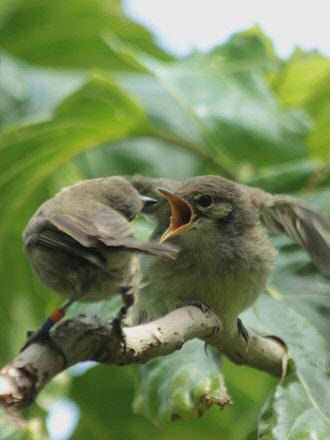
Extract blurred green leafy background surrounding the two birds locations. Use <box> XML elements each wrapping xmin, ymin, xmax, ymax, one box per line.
<box><xmin>0</xmin><ymin>0</ymin><xmax>330</xmax><ymax>440</ymax></box>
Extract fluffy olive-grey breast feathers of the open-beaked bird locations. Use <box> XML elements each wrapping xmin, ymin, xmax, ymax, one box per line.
<box><xmin>140</xmin><ymin>230</ymin><xmax>276</xmax><ymax>325</ymax></box>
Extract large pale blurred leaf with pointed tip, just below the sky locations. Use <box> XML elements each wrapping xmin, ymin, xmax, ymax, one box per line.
<box><xmin>107</xmin><ymin>28</ymin><xmax>310</xmax><ymax>171</ymax></box>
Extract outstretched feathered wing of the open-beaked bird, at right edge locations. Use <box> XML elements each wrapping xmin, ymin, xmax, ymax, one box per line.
<box><xmin>260</xmin><ymin>196</ymin><xmax>330</xmax><ymax>276</ymax></box>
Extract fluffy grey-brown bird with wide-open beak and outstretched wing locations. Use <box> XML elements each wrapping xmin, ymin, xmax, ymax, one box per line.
<box><xmin>131</xmin><ymin>176</ymin><xmax>330</xmax><ymax>337</ymax></box>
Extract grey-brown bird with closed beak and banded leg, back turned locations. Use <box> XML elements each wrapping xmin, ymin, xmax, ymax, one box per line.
<box><xmin>23</xmin><ymin>177</ymin><xmax>176</xmax><ymax>344</ymax></box>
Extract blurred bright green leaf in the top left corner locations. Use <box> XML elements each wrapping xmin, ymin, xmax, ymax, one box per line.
<box><xmin>0</xmin><ymin>0</ymin><xmax>170</xmax><ymax>70</ymax></box>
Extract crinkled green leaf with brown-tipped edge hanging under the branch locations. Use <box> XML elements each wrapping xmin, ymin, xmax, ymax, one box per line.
<box><xmin>133</xmin><ymin>340</ymin><xmax>231</xmax><ymax>426</ymax></box>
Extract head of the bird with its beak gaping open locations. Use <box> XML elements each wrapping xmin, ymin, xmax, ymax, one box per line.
<box><xmin>158</xmin><ymin>176</ymin><xmax>258</xmax><ymax>242</ymax></box>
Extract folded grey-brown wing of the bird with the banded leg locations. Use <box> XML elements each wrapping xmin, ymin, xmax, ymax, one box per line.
<box><xmin>48</xmin><ymin>209</ymin><xmax>132</xmax><ymax>248</ymax></box>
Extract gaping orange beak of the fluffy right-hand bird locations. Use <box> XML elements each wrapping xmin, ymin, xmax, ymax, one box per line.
<box><xmin>157</xmin><ymin>188</ymin><xmax>196</xmax><ymax>243</ymax></box>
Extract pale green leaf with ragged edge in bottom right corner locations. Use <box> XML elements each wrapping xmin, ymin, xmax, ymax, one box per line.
<box><xmin>258</xmin><ymin>374</ymin><xmax>330</xmax><ymax>440</ymax></box>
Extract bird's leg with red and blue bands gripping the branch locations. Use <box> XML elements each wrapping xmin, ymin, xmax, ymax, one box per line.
<box><xmin>20</xmin><ymin>281</ymin><xmax>91</xmax><ymax>365</ymax></box>
